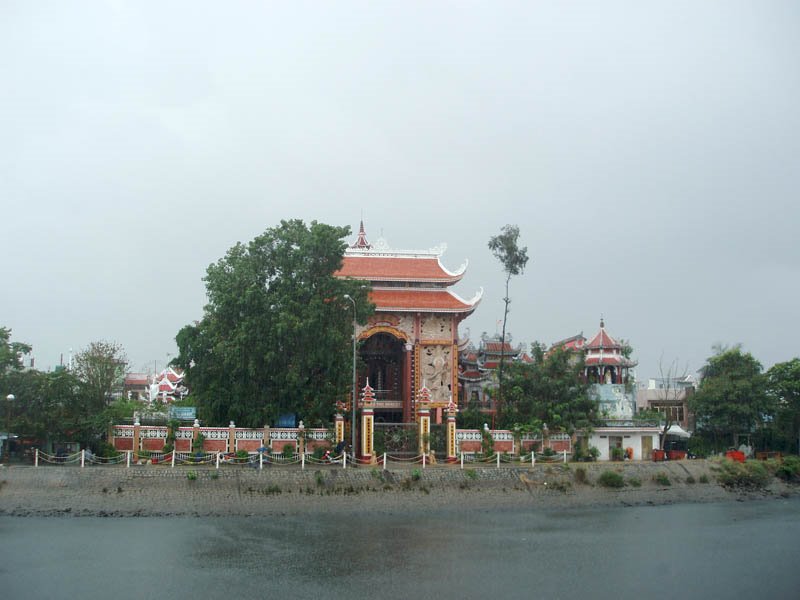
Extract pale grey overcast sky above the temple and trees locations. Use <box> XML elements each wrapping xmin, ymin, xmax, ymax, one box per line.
<box><xmin>0</xmin><ymin>0</ymin><xmax>800</xmax><ymax>379</ymax></box>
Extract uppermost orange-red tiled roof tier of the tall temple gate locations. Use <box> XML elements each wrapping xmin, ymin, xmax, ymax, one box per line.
<box><xmin>336</xmin><ymin>254</ymin><xmax>464</xmax><ymax>283</ymax></box>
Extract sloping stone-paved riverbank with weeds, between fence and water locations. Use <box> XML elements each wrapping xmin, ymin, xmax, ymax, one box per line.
<box><xmin>0</xmin><ymin>460</ymin><xmax>800</xmax><ymax>517</ymax></box>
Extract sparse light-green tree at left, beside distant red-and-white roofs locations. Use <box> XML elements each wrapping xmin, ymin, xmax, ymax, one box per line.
<box><xmin>74</xmin><ymin>341</ymin><xmax>128</xmax><ymax>413</ymax></box>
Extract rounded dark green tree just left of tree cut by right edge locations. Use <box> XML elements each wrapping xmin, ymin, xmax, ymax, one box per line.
<box><xmin>689</xmin><ymin>347</ymin><xmax>774</xmax><ymax>449</ymax></box>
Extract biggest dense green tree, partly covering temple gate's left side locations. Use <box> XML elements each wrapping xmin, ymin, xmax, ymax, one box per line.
<box><xmin>174</xmin><ymin>220</ymin><xmax>374</xmax><ymax>427</ymax></box>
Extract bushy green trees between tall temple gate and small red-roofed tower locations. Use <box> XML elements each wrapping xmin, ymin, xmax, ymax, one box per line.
<box><xmin>499</xmin><ymin>343</ymin><xmax>598</xmax><ymax>433</ymax></box>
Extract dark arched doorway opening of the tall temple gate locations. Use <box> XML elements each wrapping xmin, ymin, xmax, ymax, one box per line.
<box><xmin>360</xmin><ymin>333</ymin><xmax>408</xmax><ymax>423</ymax></box>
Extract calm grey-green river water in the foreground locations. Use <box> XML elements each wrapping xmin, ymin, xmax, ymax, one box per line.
<box><xmin>0</xmin><ymin>499</ymin><xmax>800</xmax><ymax>600</ymax></box>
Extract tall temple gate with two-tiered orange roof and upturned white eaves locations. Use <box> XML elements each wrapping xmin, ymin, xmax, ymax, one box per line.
<box><xmin>336</xmin><ymin>221</ymin><xmax>483</xmax><ymax>423</ymax></box>
